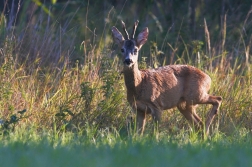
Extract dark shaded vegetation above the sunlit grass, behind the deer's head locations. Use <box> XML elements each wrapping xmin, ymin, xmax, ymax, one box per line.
<box><xmin>0</xmin><ymin>0</ymin><xmax>252</xmax><ymax>66</ymax></box>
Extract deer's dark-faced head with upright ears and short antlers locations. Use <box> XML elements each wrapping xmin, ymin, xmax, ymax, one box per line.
<box><xmin>112</xmin><ymin>21</ymin><xmax>149</xmax><ymax>68</ymax></box>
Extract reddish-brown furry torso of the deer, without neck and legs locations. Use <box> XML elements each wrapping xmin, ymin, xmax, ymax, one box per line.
<box><xmin>136</xmin><ymin>65</ymin><xmax>211</xmax><ymax>109</ymax></box>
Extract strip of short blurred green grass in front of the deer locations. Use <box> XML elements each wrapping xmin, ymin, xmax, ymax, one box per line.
<box><xmin>0</xmin><ymin>129</ymin><xmax>252</xmax><ymax>167</ymax></box>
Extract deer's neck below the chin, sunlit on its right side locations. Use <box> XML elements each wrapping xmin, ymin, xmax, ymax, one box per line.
<box><xmin>123</xmin><ymin>63</ymin><xmax>142</xmax><ymax>93</ymax></box>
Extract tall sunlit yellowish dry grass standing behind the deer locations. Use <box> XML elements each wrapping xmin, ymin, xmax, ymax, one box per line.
<box><xmin>0</xmin><ymin>0</ymin><xmax>252</xmax><ymax>141</ymax></box>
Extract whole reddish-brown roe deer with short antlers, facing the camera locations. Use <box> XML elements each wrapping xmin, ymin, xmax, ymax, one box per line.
<box><xmin>112</xmin><ymin>21</ymin><xmax>222</xmax><ymax>135</ymax></box>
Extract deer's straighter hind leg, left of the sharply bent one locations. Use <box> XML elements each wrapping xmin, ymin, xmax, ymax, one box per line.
<box><xmin>177</xmin><ymin>101</ymin><xmax>203</xmax><ymax>132</ymax></box>
